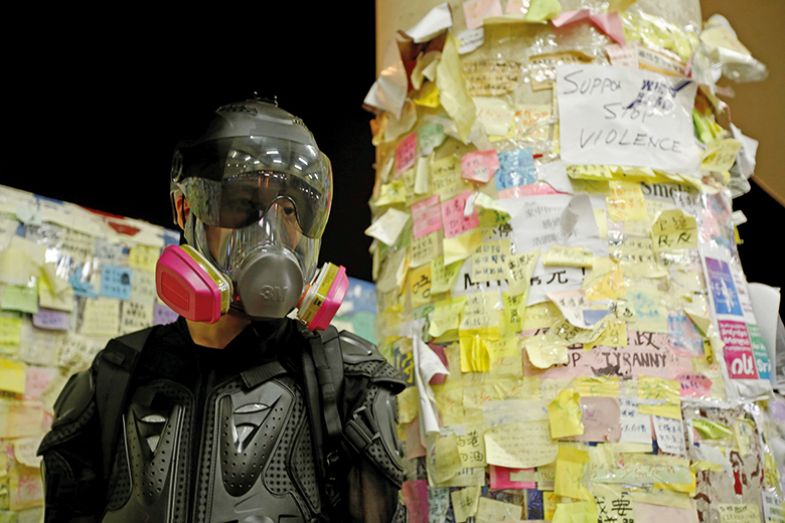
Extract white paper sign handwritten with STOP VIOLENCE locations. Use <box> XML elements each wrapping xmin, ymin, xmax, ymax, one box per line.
<box><xmin>556</xmin><ymin>64</ymin><xmax>700</xmax><ymax>172</ymax></box>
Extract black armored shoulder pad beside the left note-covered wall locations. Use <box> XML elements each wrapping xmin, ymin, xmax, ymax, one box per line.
<box><xmin>38</xmin><ymin>369</ymin><xmax>95</xmax><ymax>455</ymax></box>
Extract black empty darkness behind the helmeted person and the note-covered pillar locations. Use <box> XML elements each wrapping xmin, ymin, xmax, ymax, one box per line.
<box><xmin>0</xmin><ymin>6</ymin><xmax>785</xmax><ymax>310</ymax></box>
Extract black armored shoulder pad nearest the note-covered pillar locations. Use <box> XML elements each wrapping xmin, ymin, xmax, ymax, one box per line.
<box><xmin>338</xmin><ymin>331</ymin><xmax>406</xmax><ymax>394</ymax></box>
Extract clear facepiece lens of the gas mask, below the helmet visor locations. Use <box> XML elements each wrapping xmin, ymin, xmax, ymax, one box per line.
<box><xmin>195</xmin><ymin>199</ymin><xmax>320</xmax><ymax>282</ymax></box>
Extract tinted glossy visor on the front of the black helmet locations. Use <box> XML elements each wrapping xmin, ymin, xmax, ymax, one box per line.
<box><xmin>174</xmin><ymin>136</ymin><xmax>332</xmax><ymax>239</ymax></box>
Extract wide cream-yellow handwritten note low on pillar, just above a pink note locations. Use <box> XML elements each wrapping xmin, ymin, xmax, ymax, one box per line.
<box><xmin>485</xmin><ymin>420</ymin><xmax>558</xmax><ymax>468</ymax></box>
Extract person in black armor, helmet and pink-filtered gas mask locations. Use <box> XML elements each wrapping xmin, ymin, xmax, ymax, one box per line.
<box><xmin>39</xmin><ymin>100</ymin><xmax>405</xmax><ymax>523</ymax></box>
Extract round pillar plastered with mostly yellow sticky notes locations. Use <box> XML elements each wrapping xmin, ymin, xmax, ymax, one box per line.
<box><xmin>365</xmin><ymin>0</ymin><xmax>785</xmax><ymax>523</ymax></box>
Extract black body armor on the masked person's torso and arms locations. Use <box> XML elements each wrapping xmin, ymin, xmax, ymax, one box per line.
<box><xmin>39</xmin><ymin>320</ymin><xmax>403</xmax><ymax>523</ymax></box>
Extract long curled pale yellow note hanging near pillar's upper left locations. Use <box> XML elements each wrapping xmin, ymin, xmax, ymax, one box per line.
<box><xmin>436</xmin><ymin>35</ymin><xmax>476</xmax><ymax>143</ymax></box>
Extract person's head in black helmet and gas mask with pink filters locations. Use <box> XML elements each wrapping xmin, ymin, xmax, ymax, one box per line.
<box><xmin>156</xmin><ymin>100</ymin><xmax>348</xmax><ymax>330</ymax></box>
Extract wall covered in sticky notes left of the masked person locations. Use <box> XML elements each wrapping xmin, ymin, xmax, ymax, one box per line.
<box><xmin>0</xmin><ymin>186</ymin><xmax>179</xmax><ymax>521</ymax></box>
